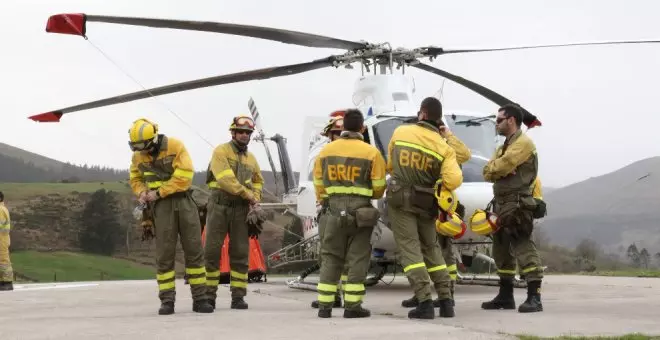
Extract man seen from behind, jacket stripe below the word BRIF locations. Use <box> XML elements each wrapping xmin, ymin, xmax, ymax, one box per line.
<box><xmin>314</xmin><ymin>109</ymin><xmax>385</xmax><ymax>318</ymax></box>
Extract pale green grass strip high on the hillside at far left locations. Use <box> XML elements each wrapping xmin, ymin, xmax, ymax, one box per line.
<box><xmin>0</xmin><ymin>182</ymin><xmax>131</xmax><ymax>201</ymax></box>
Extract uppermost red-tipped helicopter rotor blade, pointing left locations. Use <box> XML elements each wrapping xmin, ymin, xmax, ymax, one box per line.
<box><xmin>46</xmin><ymin>13</ymin><xmax>368</xmax><ymax>50</ymax></box>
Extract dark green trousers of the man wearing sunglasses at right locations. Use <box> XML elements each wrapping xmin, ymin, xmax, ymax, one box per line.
<box><xmin>493</xmin><ymin>205</ymin><xmax>543</xmax><ymax>282</ymax></box>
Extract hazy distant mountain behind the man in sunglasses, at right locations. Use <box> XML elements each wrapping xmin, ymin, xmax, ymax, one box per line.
<box><xmin>540</xmin><ymin>157</ymin><xmax>660</xmax><ymax>252</ymax></box>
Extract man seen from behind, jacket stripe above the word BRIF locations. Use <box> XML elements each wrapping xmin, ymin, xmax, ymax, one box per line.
<box><xmin>387</xmin><ymin>97</ymin><xmax>463</xmax><ymax>319</ymax></box>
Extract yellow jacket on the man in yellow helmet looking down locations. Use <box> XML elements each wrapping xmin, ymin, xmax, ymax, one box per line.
<box><xmin>130</xmin><ymin>136</ymin><xmax>195</xmax><ymax>198</ymax></box>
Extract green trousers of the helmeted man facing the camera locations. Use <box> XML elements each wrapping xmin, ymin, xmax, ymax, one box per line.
<box><xmin>204</xmin><ymin>195</ymin><xmax>250</xmax><ymax>300</ymax></box>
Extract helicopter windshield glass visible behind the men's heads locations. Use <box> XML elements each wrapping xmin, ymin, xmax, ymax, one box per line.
<box><xmin>373</xmin><ymin>115</ymin><xmax>497</xmax><ymax>183</ymax></box>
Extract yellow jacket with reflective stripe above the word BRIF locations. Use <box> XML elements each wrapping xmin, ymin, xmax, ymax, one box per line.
<box><xmin>387</xmin><ymin>122</ymin><xmax>463</xmax><ymax>191</ymax></box>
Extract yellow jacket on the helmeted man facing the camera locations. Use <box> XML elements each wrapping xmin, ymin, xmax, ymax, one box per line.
<box><xmin>206</xmin><ymin>141</ymin><xmax>264</xmax><ymax>201</ymax></box>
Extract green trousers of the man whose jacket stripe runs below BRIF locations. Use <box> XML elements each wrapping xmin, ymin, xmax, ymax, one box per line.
<box><xmin>317</xmin><ymin>196</ymin><xmax>373</xmax><ymax>310</ymax></box>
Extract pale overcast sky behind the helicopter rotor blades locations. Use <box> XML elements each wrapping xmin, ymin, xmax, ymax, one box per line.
<box><xmin>0</xmin><ymin>0</ymin><xmax>660</xmax><ymax>187</ymax></box>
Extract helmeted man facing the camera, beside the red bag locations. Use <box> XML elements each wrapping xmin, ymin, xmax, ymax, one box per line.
<box><xmin>205</xmin><ymin>115</ymin><xmax>264</xmax><ymax>309</ymax></box>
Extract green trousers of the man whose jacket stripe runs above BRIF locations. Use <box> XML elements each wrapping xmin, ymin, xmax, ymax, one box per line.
<box><xmin>387</xmin><ymin>205</ymin><xmax>451</xmax><ymax>302</ymax></box>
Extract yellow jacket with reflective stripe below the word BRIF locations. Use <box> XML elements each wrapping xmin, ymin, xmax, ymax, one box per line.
<box><xmin>314</xmin><ymin>132</ymin><xmax>385</xmax><ymax>202</ymax></box>
